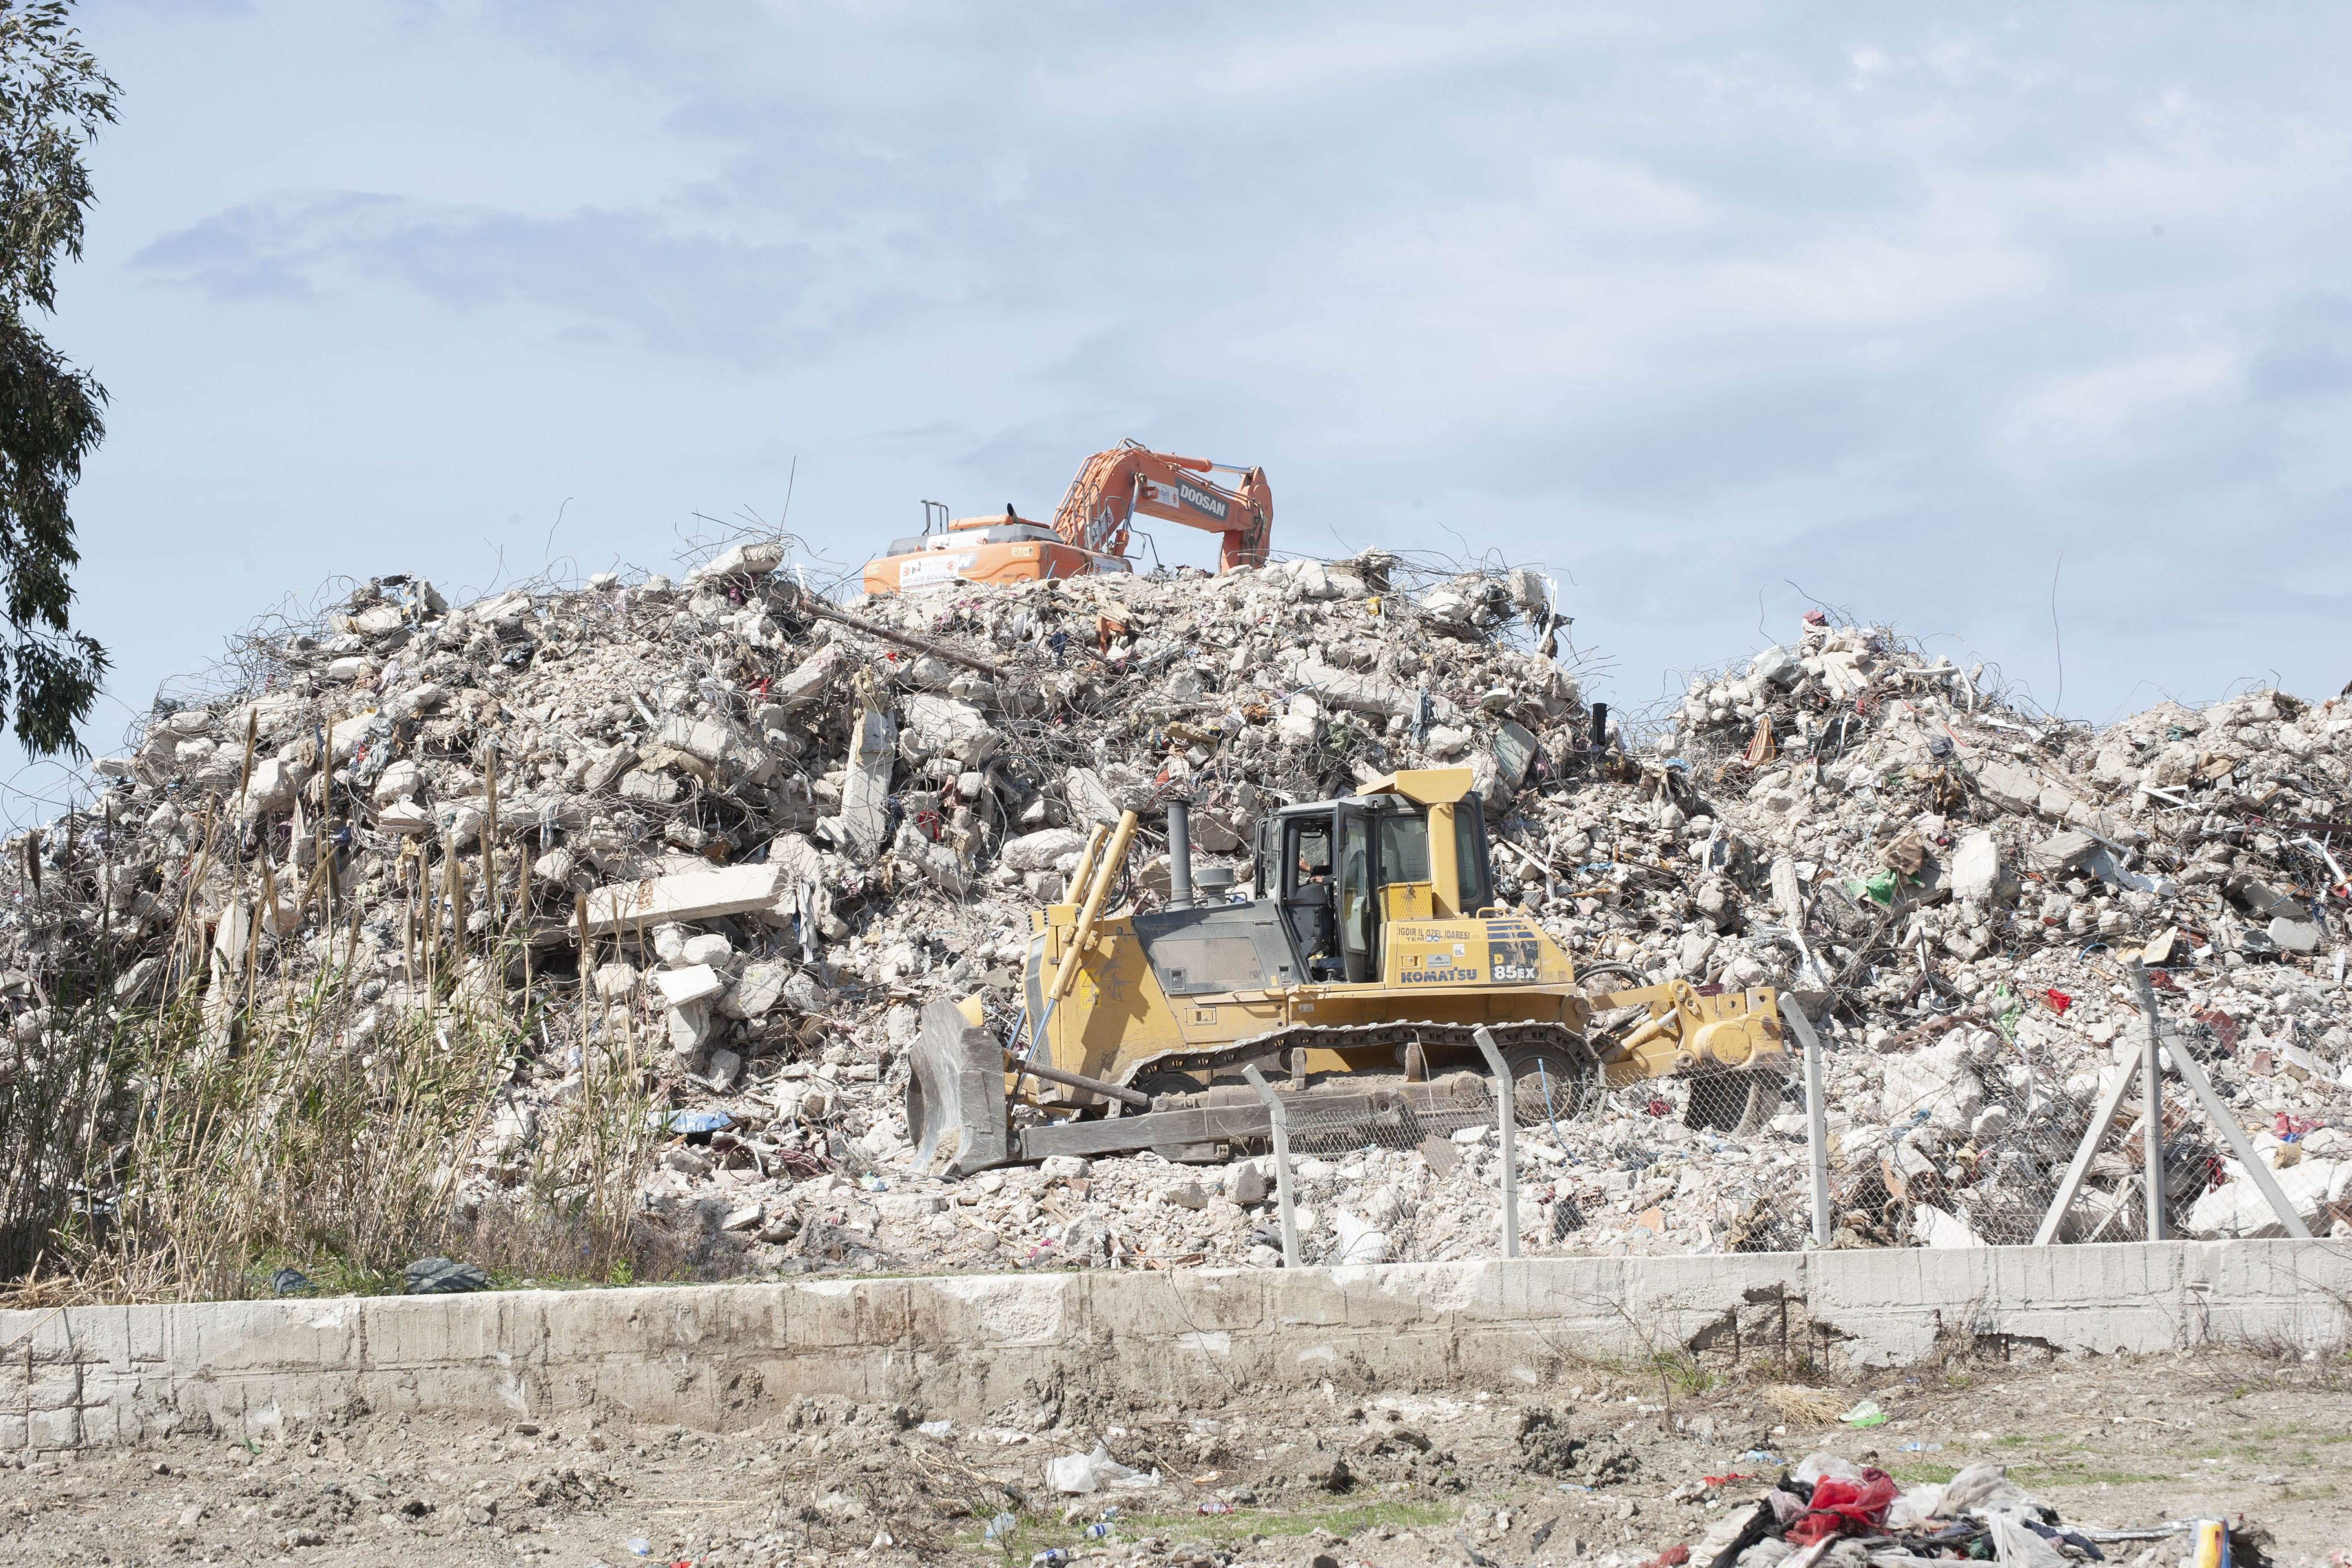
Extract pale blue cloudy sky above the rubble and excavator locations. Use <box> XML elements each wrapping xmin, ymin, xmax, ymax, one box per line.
<box><xmin>19</xmin><ymin>0</ymin><xmax>2352</xmax><ymax>808</ymax></box>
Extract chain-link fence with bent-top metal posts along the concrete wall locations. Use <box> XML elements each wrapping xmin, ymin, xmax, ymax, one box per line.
<box><xmin>1232</xmin><ymin>963</ymin><xmax>2352</xmax><ymax>1265</ymax></box>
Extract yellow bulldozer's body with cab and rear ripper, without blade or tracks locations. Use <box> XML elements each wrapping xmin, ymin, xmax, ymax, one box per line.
<box><xmin>1009</xmin><ymin>768</ymin><xmax>1785</xmax><ymax>1110</ymax></box>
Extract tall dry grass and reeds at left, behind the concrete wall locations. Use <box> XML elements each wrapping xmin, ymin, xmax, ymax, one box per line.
<box><xmin>0</xmin><ymin>771</ymin><xmax>682</xmax><ymax>1307</ymax></box>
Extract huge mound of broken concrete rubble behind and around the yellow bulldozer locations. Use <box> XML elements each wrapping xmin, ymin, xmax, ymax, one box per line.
<box><xmin>0</xmin><ymin>541</ymin><xmax>2352</xmax><ymax>1274</ymax></box>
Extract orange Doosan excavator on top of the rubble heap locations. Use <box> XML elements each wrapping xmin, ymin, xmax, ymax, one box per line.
<box><xmin>865</xmin><ymin>442</ymin><xmax>1275</xmax><ymax>595</ymax></box>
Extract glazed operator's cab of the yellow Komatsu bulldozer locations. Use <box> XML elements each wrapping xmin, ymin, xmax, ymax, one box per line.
<box><xmin>1254</xmin><ymin>768</ymin><xmax>1493</xmax><ymax>985</ymax></box>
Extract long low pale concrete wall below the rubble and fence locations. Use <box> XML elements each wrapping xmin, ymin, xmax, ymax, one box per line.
<box><xmin>0</xmin><ymin>1241</ymin><xmax>2352</xmax><ymax>1451</ymax></box>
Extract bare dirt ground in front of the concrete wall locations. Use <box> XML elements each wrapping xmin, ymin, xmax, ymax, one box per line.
<box><xmin>0</xmin><ymin>1352</ymin><xmax>2352</xmax><ymax>1568</ymax></box>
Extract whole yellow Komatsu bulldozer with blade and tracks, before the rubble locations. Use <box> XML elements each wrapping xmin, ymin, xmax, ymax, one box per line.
<box><xmin>908</xmin><ymin>768</ymin><xmax>1790</xmax><ymax>1175</ymax></box>
